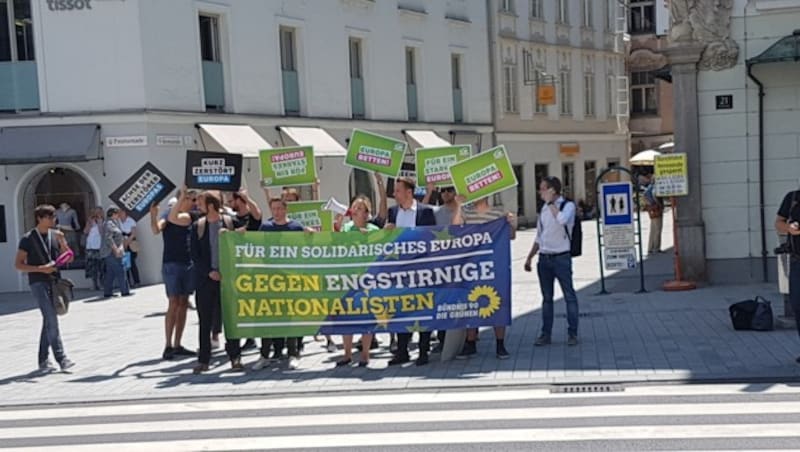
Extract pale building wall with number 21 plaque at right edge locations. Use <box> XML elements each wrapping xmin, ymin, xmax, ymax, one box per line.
<box><xmin>688</xmin><ymin>0</ymin><xmax>800</xmax><ymax>282</ymax></box>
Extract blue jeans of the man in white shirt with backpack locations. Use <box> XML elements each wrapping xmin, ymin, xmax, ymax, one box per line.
<box><xmin>536</xmin><ymin>253</ymin><xmax>578</xmax><ymax>337</ymax></box>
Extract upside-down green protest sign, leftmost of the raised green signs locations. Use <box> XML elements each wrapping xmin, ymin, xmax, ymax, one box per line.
<box><xmin>259</xmin><ymin>146</ymin><xmax>317</xmax><ymax>187</ymax></box>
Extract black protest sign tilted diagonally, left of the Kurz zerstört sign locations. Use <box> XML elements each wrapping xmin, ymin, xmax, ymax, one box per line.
<box><xmin>108</xmin><ymin>162</ymin><xmax>175</xmax><ymax>221</ymax></box>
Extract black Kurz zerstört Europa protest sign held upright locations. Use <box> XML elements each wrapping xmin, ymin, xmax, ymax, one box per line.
<box><xmin>186</xmin><ymin>151</ymin><xmax>242</xmax><ymax>191</ymax></box>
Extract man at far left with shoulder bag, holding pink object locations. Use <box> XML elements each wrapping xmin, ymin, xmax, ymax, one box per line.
<box><xmin>14</xmin><ymin>204</ymin><xmax>75</xmax><ymax>372</ymax></box>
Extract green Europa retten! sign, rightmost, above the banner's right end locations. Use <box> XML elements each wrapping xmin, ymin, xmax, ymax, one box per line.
<box><xmin>450</xmin><ymin>145</ymin><xmax>517</xmax><ymax>202</ymax></box>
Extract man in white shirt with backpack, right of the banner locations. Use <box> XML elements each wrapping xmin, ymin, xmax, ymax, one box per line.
<box><xmin>525</xmin><ymin>177</ymin><xmax>578</xmax><ymax>346</ymax></box>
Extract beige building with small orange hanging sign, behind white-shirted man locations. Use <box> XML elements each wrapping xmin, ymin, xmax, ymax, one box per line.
<box><xmin>489</xmin><ymin>0</ymin><xmax>628</xmax><ymax>226</ymax></box>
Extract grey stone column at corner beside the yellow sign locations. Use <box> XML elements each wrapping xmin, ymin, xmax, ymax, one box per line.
<box><xmin>663</xmin><ymin>43</ymin><xmax>706</xmax><ymax>281</ymax></box>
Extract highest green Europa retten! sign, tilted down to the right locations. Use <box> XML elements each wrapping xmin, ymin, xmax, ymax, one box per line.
<box><xmin>344</xmin><ymin>129</ymin><xmax>408</xmax><ymax>177</ymax></box>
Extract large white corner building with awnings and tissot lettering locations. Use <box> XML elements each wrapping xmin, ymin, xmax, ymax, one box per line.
<box><xmin>0</xmin><ymin>0</ymin><xmax>493</xmax><ymax>291</ymax></box>
